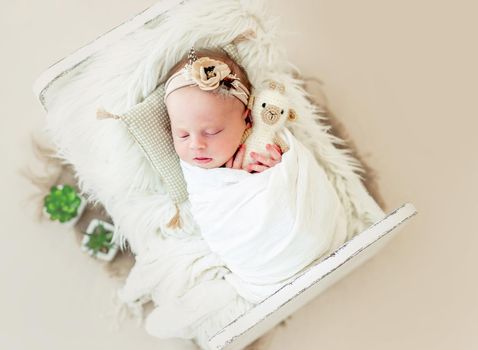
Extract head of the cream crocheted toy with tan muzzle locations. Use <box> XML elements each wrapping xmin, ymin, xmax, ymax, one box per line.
<box><xmin>252</xmin><ymin>89</ymin><xmax>289</xmax><ymax>130</ymax></box>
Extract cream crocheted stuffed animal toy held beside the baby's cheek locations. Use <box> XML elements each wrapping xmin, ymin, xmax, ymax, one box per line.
<box><xmin>242</xmin><ymin>81</ymin><xmax>297</xmax><ymax>169</ymax></box>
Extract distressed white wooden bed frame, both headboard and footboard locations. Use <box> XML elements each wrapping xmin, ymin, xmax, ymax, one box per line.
<box><xmin>33</xmin><ymin>0</ymin><xmax>417</xmax><ymax>350</ymax></box>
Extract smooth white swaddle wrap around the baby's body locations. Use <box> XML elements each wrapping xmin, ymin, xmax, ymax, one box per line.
<box><xmin>181</xmin><ymin>130</ymin><xmax>347</xmax><ymax>303</ymax></box>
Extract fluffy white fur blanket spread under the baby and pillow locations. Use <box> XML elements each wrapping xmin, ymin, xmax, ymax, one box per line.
<box><xmin>40</xmin><ymin>0</ymin><xmax>383</xmax><ymax>347</ymax></box>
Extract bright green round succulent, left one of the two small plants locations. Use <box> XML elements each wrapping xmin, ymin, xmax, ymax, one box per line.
<box><xmin>44</xmin><ymin>185</ymin><xmax>81</xmax><ymax>223</ymax></box>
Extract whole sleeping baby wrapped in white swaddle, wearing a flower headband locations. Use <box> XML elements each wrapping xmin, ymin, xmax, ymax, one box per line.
<box><xmin>165</xmin><ymin>50</ymin><xmax>347</xmax><ymax>303</ymax></box>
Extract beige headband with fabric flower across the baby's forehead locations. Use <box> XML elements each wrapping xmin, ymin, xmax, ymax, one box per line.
<box><xmin>164</xmin><ymin>48</ymin><xmax>250</xmax><ymax>107</ymax></box>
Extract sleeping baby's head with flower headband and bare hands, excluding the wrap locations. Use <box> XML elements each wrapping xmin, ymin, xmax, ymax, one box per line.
<box><xmin>165</xmin><ymin>47</ymin><xmax>281</xmax><ymax>172</ymax></box>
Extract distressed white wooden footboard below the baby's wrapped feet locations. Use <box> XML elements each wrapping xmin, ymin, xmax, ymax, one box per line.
<box><xmin>209</xmin><ymin>203</ymin><xmax>417</xmax><ymax>350</ymax></box>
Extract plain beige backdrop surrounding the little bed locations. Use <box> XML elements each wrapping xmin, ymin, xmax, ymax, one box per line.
<box><xmin>0</xmin><ymin>0</ymin><xmax>478</xmax><ymax>350</ymax></box>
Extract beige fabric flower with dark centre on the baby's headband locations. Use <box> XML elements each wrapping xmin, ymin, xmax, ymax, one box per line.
<box><xmin>191</xmin><ymin>57</ymin><xmax>231</xmax><ymax>91</ymax></box>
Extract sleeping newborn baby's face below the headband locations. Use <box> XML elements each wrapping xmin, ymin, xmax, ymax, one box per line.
<box><xmin>166</xmin><ymin>86</ymin><xmax>247</xmax><ymax>169</ymax></box>
